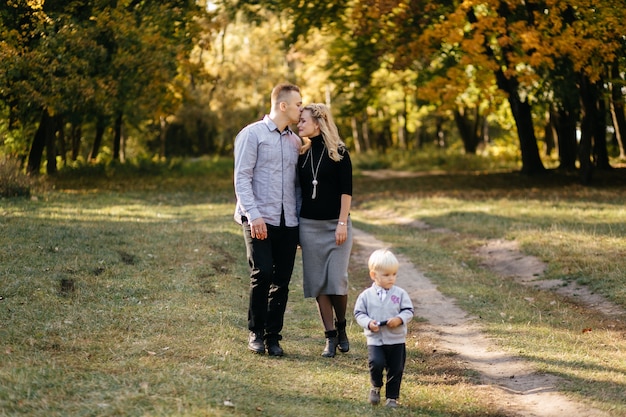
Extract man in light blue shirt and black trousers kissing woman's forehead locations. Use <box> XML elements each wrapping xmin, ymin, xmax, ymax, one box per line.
<box><xmin>234</xmin><ymin>83</ymin><xmax>302</xmax><ymax>356</ymax></box>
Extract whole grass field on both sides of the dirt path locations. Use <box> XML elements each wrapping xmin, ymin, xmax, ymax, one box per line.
<box><xmin>0</xmin><ymin>161</ymin><xmax>626</xmax><ymax>417</ymax></box>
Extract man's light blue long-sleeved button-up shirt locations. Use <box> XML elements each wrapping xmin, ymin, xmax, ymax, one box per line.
<box><xmin>234</xmin><ymin>115</ymin><xmax>302</xmax><ymax>227</ymax></box>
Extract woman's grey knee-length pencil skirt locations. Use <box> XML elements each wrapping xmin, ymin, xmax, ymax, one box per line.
<box><xmin>300</xmin><ymin>218</ymin><xmax>352</xmax><ymax>298</ymax></box>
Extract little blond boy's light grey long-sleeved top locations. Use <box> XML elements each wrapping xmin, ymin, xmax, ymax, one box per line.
<box><xmin>354</xmin><ymin>284</ymin><xmax>413</xmax><ymax>346</ymax></box>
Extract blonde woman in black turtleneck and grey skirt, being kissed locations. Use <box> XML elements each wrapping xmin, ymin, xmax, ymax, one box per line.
<box><xmin>298</xmin><ymin>103</ymin><xmax>352</xmax><ymax>358</ymax></box>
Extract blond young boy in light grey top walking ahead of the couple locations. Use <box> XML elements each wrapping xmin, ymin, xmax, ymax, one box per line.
<box><xmin>354</xmin><ymin>249</ymin><xmax>413</xmax><ymax>407</ymax></box>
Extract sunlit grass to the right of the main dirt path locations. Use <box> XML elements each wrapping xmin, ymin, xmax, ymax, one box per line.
<box><xmin>353</xmin><ymin>169</ymin><xmax>626</xmax><ymax>415</ymax></box>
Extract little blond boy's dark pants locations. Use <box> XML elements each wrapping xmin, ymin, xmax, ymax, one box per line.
<box><xmin>367</xmin><ymin>343</ymin><xmax>406</xmax><ymax>400</ymax></box>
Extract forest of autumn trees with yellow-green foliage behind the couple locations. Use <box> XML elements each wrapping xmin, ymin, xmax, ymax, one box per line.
<box><xmin>0</xmin><ymin>0</ymin><xmax>626</xmax><ymax>186</ymax></box>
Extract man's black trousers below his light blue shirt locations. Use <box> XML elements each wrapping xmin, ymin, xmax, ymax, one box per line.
<box><xmin>243</xmin><ymin>219</ymin><xmax>298</xmax><ymax>340</ymax></box>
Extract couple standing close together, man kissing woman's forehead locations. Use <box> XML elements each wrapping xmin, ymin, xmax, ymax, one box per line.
<box><xmin>234</xmin><ymin>83</ymin><xmax>352</xmax><ymax>357</ymax></box>
